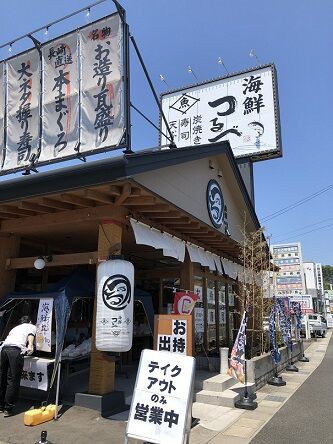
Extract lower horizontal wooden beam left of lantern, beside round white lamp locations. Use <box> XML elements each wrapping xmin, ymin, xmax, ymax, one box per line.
<box><xmin>6</xmin><ymin>251</ymin><xmax>97</xmax><ymax>270</ymax></box>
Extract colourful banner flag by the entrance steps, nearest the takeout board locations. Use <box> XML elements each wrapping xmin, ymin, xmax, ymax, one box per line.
<box><xmin>227</xmin><ymin>311</ymin><xmax>247</xmax><ymax>384</ymax></box>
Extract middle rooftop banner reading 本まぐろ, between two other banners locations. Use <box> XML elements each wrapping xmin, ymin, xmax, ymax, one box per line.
<box><xmin>39</xmin><ymin>33</ymin><xmax>79</xmax><ymax>162</ymax></box>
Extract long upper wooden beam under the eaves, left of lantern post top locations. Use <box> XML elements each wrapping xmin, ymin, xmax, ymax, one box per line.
<box><xmin>0</xmin><ymin>205</ymin><xmax>128</xmax><ymax>233</ymax></box>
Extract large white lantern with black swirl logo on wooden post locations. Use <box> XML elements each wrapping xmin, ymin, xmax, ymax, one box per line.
<box><xmin>96</xmin><ymin>259</ymin><xmax>134</xmax><ymax>352</ymax></box>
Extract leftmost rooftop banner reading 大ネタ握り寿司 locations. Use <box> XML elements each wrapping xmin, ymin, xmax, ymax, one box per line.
<box><xmin>3</xmin><ymin>49</ymin><xmax>40</xmax><ymax>170</ymax></box>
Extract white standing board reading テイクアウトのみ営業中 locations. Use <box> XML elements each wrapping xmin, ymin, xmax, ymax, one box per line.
<box><xmin>125</xmin><ymin>350</ymin><xmax>195</xmax><ymax>444</ymax></box>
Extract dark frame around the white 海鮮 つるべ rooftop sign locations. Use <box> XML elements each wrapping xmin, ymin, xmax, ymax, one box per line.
<box><xmin>158</xmin><ymin>63</ymin><xmax>283</xmax><ymax>162</ymax></box>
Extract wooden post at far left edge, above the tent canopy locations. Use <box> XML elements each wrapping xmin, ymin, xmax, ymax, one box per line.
<box><xmin>0</xmin><ymin>233</ymin><xmax>20</xmax><ymax>299</ymax></box>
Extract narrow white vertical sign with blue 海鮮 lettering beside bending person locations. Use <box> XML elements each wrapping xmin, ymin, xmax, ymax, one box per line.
<box><xmin>36</xmin><ymin>299</ymin><xmax>53</xmax><ymax>352</ymax></box>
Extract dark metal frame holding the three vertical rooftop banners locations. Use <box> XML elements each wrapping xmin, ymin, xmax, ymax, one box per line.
<box><xmin>0</xmin><ymin>12</ymin><xmax>131</xmax><ymax>177</ymax></box>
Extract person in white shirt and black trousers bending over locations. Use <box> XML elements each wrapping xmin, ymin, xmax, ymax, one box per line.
<box><xmin>0</xmin><ymin>316</ymin><xmax>37</xmax><ymax>417</ymax></box>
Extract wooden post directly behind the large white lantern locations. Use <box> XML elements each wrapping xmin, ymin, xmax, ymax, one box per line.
<box><xmin>89</xmin><ymin>221</ymin><xmax>122</xmax><ymax>395</ymax></box>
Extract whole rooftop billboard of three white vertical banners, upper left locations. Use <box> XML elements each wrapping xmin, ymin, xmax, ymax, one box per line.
<box><xmin>0</xmin><ymin>13</ymin><xmax>129</xmax><ymax>175</ymax></box>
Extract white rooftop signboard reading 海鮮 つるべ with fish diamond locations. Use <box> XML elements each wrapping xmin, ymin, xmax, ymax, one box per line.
<box><xmin>161</xmin><ymin>65</ymin><xmax>282</xmax><ymax>161</ymax></box>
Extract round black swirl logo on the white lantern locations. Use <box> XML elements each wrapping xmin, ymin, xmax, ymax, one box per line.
<box><xmin>102</xmin><ymin>274</ymin><xmax>131</xmax><ymax>310</ymax></box>
